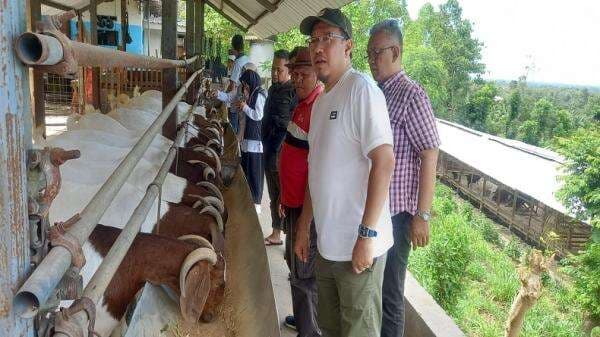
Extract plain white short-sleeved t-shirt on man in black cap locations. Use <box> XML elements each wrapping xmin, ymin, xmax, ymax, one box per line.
<box><xmin>308</xmin><ymin>68</ymin><xmax>394</xmax><ymax>261</ymax></box>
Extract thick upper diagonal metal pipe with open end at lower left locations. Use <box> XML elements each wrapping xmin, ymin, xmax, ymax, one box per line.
<box><xmin>13</xmin><ymin>69</ymin><xmax>202</xmax><ymax>318</ymax></box>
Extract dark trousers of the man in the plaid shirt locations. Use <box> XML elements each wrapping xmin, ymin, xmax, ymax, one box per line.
<box><xmin>381</xmin><ymin>212</ymin><xmax>412</xmax><ymax>337</ymax></box>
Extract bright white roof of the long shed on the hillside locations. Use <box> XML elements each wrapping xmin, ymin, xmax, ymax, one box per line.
<box><xmin>437</xmin><ymin>119</ymin><xmax>569</xmax><ymax>215</ymax></box>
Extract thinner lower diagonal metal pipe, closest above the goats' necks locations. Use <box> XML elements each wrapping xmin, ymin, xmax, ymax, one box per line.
<box><xmin>53</xmin><ymin>87</ymin><xmax>198</xmax><ymax>337</ymax></box>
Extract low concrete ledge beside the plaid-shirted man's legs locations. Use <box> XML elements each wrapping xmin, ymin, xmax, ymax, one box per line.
<box><xmin>404</xmin><ymin>272</ymin><xmax>465</xmax><ymax>337</ymax></box>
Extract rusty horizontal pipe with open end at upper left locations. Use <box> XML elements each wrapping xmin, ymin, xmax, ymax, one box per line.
<box><xmin>15</xmin><ymin>32</ymin><xmax>198</xmax><ymax>69</ymax></box>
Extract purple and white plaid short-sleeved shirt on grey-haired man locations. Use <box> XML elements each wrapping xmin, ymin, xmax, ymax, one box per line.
<box><xmin>380</xmin><ymin>71</ymin><xmax>440</xmax><ymax>215</ymax></box>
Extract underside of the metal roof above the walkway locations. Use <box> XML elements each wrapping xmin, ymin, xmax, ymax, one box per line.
<box><xmin>42</xmin><ymin>0</ymin><xmax>352</xmax><ymax>38</ymax></box>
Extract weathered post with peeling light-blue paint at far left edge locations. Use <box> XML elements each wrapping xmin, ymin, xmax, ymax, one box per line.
<box><xmin>0</xmin><ymin>0</ymin><xmax>33</xmax><ymax>336</ymax></box>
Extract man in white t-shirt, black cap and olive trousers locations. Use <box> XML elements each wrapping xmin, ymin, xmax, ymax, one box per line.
<box><xmin>295</xmin><ymin>8</ymin><xmax>394</xmax><ymax>337</ymax></box>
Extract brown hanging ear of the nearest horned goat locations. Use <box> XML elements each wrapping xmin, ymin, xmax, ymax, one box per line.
<box><xmin>179</xmin><ymin>261</ymin><xmax>210</xmax><ymax>323</ymax></box>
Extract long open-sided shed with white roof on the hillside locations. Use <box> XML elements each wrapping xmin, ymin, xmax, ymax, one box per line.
<box><xmin>437</xmin><ymin>119</ymin><xmax>591</xmax><ymax>255</ymax></box>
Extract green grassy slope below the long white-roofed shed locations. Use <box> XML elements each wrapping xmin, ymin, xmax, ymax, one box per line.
<box><xmin>409</xmin><ymin>184</ymin><xmax>583</xmax><ymax>337</ymax></box>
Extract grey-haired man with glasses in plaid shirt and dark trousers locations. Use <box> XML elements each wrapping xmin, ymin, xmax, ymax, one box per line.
<box><xmin>367</xmin><ymin>20</ymin><xmax>440</xmax><ymax>337</ymax></box>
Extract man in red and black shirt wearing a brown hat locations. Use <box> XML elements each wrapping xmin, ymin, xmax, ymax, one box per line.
<box><xmin>279</xmin><ymin>47</ymin><xmax>323</xmax><ymax>337</ymax></box>
